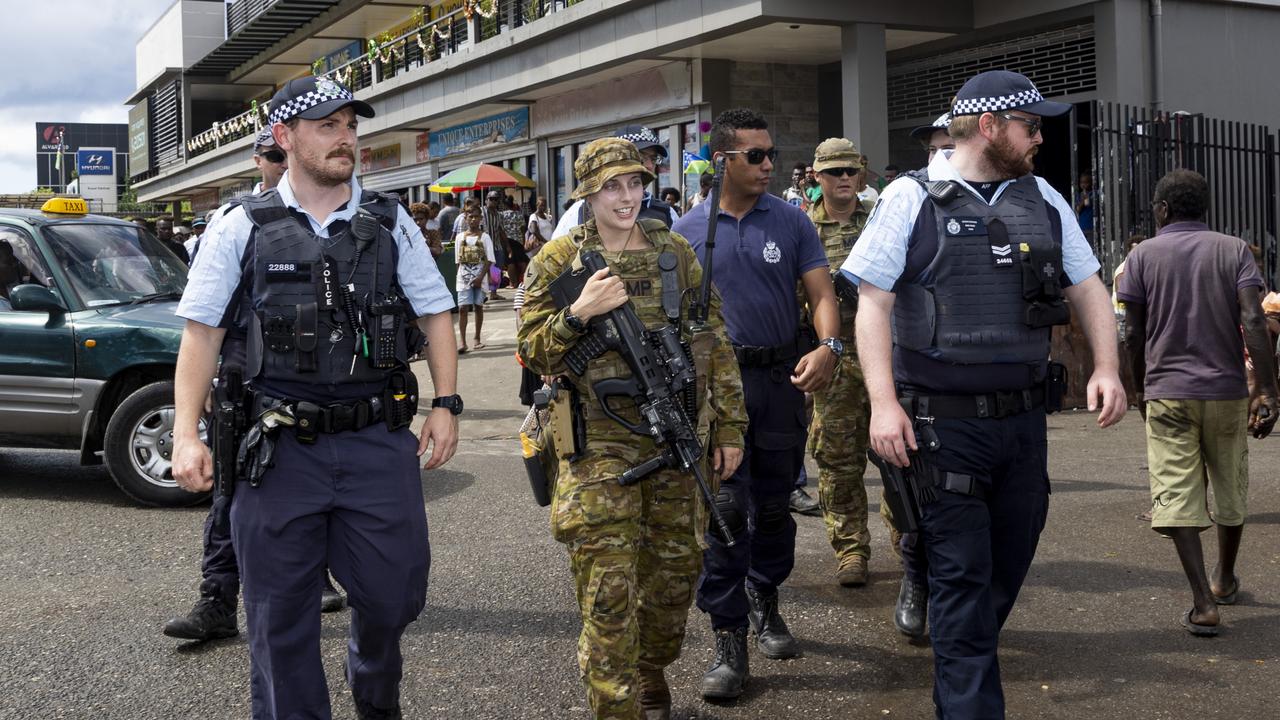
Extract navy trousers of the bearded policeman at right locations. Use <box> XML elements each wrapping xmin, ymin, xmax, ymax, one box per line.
<box><xmin>920</xmin><ymin>409</ymin><xmax>1050</xmax><ymax>720</ymax></box>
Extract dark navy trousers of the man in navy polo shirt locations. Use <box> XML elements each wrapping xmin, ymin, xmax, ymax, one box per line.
<box><xmin>698</xmin><ymin>365</ymin><xmax>806</xmax><ymax>630</ymax></box>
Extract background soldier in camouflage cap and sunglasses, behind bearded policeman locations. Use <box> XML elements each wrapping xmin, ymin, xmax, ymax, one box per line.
<box><xmin>808</xmin><ymin>137</ymin><xmax>873</xmax><ymax>587</ymax></box>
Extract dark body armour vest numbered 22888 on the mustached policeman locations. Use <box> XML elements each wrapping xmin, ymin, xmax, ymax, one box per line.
<box><xmin>241</xmin><ymin>190</ymin><xmax>408</xmax><ymax>386</ymax></box>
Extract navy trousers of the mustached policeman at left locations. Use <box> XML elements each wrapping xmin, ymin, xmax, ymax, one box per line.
<box><xmin>232</xmin><ymin>424</ymin><xmax>430</xmax><ymax>720</ymax></box>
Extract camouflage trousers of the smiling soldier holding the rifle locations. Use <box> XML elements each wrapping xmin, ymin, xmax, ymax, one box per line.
<box><xmin>552</xmin><ymin>455</ymin><xmax>705</xmax><ymax>720</ymax></box>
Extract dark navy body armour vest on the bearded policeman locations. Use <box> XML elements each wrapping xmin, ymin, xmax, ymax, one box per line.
<box><xmin>893</xmin><ymin>174</ymin><xmax>1070</xmax><ymax>365</ymax></box>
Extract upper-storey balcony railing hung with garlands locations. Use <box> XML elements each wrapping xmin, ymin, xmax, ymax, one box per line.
<box><xmin>187</xmin><ymin>0</ymin><xmax>581</xmax><ymax>159</ymax></box>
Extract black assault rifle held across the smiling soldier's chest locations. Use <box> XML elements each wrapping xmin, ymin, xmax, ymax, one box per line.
<box><xmin>550</xmin><ymin>251</ymin><xmax>733</xmax><ymax>546</ymax></box>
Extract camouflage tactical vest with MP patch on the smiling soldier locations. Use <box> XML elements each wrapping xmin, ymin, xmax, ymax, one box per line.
<box><xmin>570</xmin><ymin>219</ymin><xmax>716</xmax><ymax>445</ymax></box>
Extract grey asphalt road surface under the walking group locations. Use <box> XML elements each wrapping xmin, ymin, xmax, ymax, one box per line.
<box><xmin>0</xmin><ymin>302</ymin><xmax>1280</xmax><ymax>720</ymax></box>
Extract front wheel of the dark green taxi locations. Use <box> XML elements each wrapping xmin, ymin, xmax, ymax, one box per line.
<box><xmin>102</xmin><ymin>380</ymin><xmax>209</xmax><ymax>507</ymax></box>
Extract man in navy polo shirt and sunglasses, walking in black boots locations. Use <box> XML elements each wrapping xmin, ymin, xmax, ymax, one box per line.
<box><xmin>672</xmin><ymin>109</ymin><xmax>844</xmax><ymax>698</ymax></box>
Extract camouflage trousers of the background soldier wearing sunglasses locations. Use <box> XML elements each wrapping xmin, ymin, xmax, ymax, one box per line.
<box><xmin>808</xmin><ymin>351</ymin><xmax>872</xmax><ymax>559</ymax></box>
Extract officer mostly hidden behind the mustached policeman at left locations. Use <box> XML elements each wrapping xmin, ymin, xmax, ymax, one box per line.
<box><xmin>163</xmin><ymin>120</ymin><xmax>347</xmax><ymax>641</ymax></box>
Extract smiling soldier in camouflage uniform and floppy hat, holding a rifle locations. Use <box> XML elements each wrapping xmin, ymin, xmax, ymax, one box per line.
<box><xmin>517</xmin><ymin>138</ymin><xmax>746</xmax><ymax>720</ymax></box>
